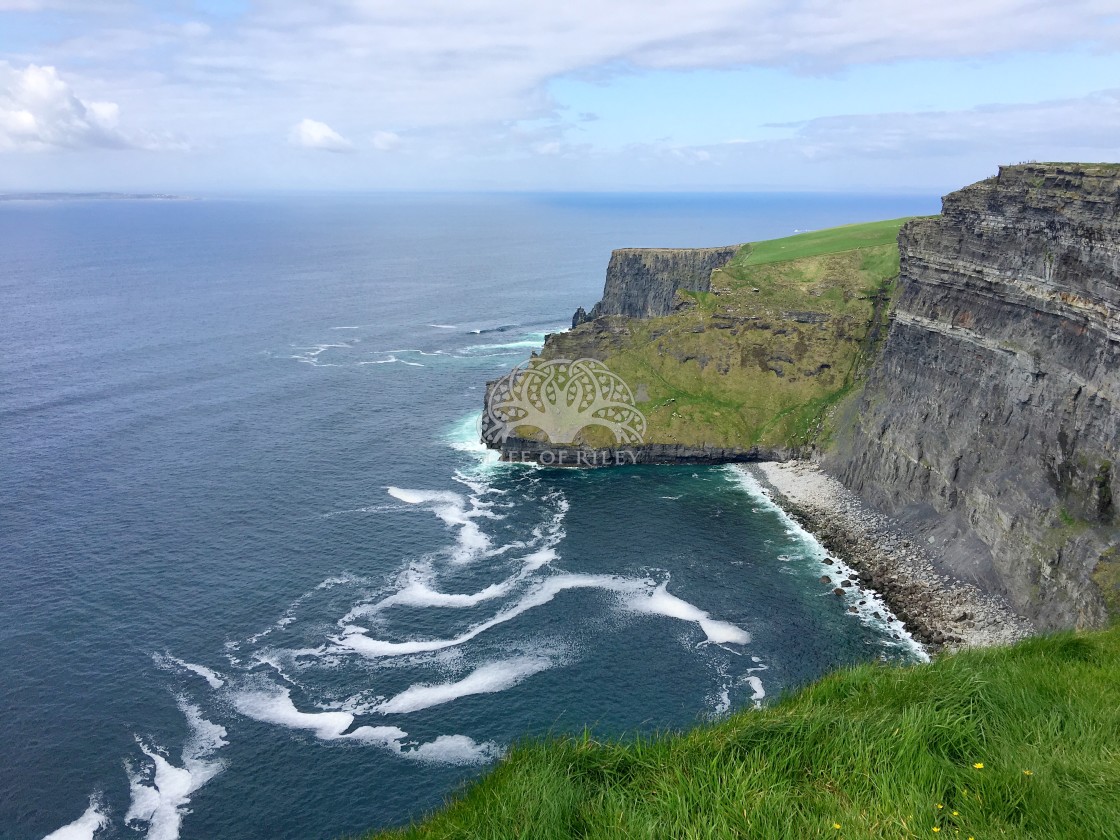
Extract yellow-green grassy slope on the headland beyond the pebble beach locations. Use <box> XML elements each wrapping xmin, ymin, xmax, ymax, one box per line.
<box><xmin>544</xmin><ymin>220</ymin><xmax>906</xmax><ymax>448</ymax></box>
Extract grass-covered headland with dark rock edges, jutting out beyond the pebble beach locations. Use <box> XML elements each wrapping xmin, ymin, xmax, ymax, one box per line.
<box><xmin>484</xmin><ymin>220</ymin><xmax>904</xmax><ymax>464</ymax></box>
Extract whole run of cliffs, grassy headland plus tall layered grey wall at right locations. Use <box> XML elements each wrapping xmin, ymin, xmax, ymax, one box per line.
<box><xmin>483</xmin><ymin>164</ymin><xmax>1120</xmax><ymax>628</ymax></box>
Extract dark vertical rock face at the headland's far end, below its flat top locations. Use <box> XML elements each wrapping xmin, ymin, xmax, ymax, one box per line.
<box><xmin>571</xmin><ymin>245</ymin><xmax>739</xmax><ymax>327</ymax></box>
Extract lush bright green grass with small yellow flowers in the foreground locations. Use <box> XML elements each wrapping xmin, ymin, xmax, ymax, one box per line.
<box><xmin>370</xmin><ymin>627</ymin><xmax>1120</xmax><ymax>840</ymax></box>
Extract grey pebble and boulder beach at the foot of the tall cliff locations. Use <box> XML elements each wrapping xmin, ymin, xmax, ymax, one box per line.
<box><xmin>745</xmin><ymin>461</ymin><xmax>1034</xmax><ymax>652</ymax></box>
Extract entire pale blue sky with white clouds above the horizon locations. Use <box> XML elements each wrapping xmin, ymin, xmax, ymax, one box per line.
<box><xmin>0</xmin><ymin>0</ymin><xmax>1120</xmax><ymax>192</ymax></box>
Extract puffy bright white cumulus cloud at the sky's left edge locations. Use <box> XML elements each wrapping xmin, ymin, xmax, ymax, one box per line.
<box><xmin>0</xmin><ymin>62</ymin><xmax>137</xmax><ymax>151</ymax></box>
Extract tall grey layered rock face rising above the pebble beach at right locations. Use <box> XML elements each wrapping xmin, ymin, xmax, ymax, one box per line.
<box><xmin>824</xmin><ymin>165</ymin><xmax>1120</xmax><ymax>628</ymax></box>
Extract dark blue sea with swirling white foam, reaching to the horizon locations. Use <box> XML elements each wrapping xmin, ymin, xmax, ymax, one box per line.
<box><xmin>0</xmin><ymin>196</ymin><xmax>936</xmax><ymax>840</ymax></box>
